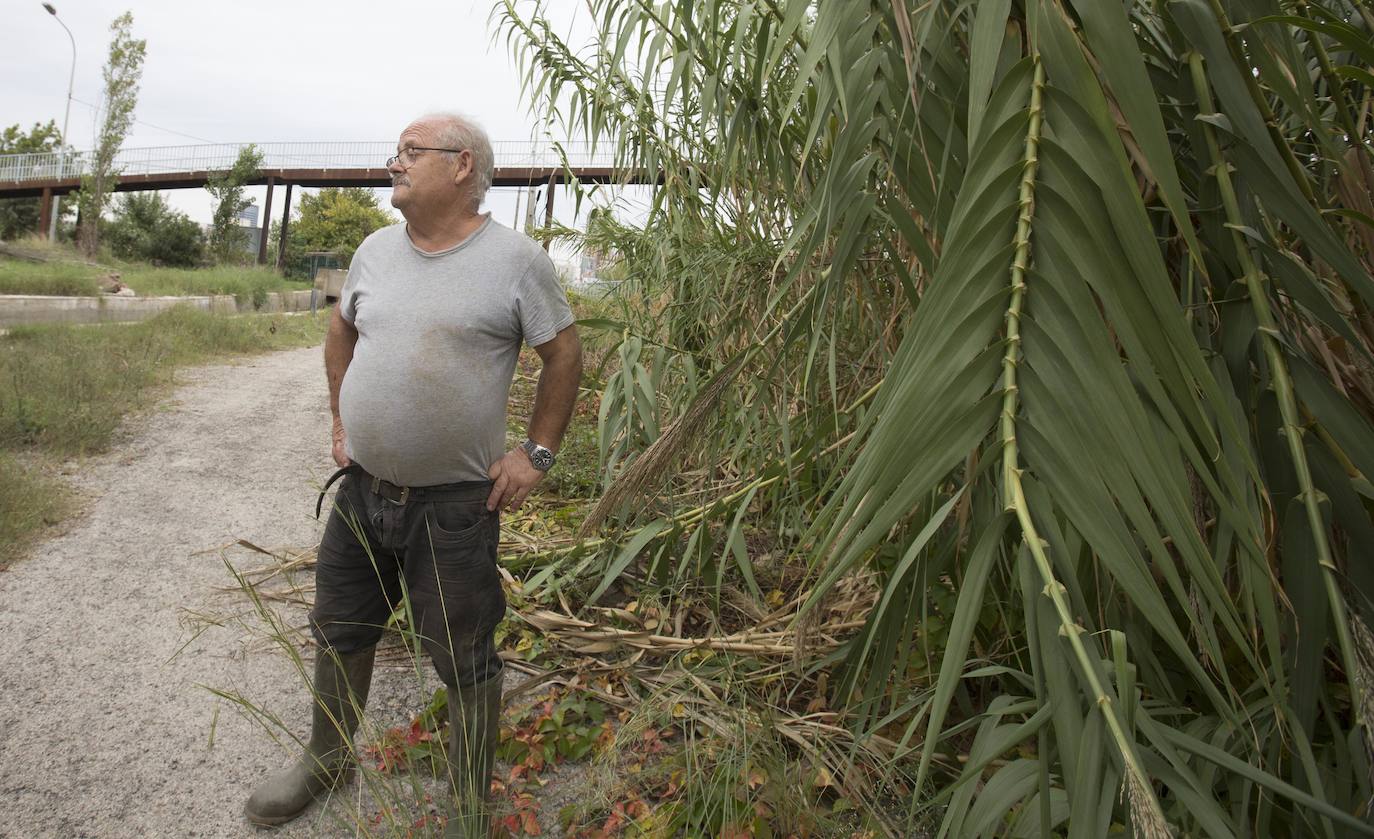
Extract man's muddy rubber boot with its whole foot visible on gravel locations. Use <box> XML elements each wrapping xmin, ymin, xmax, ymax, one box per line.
<box><xmin>243</xmin><ymin>647</ymin><xmax>376</xmax><ymax>827</ymax></box>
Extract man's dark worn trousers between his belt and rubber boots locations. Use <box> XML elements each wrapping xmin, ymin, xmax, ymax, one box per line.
<box><xmin>311</xmin><ymin>471</ymin><xmax>506</xmax><ymax>687</ymax></box>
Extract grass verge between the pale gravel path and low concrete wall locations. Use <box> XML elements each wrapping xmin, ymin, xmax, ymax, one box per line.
<box><xmin>0</xmin><ymin>308</ymin><xmax>326</xmax><ymax>567</ymax></box>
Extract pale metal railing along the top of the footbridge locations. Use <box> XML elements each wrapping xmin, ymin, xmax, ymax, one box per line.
<box><xmin>0</xmin><ymin>140</ymin><xmax>614</xmax><ymax>181</ymax></box>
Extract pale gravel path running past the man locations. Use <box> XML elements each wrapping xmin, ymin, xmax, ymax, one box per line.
<box><xmin>0</xmin><ymin>347</ymin><xmax>574</xmax><ymax>839</ymax></box>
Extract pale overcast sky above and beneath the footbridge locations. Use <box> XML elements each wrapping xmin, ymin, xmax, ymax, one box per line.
<box><xmin>0</xmin><ymin>0</ymin><xmax>643</xmax><ymax>266</ymax></box>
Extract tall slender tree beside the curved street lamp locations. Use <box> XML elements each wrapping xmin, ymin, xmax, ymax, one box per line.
<box><xmin>77</xmin><ymin>12</ymin><xmax>147</xmax><ymax>257</ymax></box>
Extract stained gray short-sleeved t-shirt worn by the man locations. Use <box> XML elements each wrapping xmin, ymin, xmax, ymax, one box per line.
<box><xmin>339</xmin><ymin>214</ymin><xmax>573</xmax><ymax>486</ymax></box>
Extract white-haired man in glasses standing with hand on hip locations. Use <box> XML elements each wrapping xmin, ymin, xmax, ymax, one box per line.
<box><xmin>246</xmin><ymin>114</ymin><xmax>581</xmax><ymax>836</ymax></box>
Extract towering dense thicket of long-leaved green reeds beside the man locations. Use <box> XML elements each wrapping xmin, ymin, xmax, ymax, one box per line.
<box><xmin>500</xmin><ymin>0</ymin><xmax>1374</xmax><ymax>838</ymax></box>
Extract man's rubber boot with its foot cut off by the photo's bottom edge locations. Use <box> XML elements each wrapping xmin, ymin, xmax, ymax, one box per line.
<box><xmin>444</xmin><ymin>676</ymin><xmax>502</xmax><ymax>839</ymax></box>
